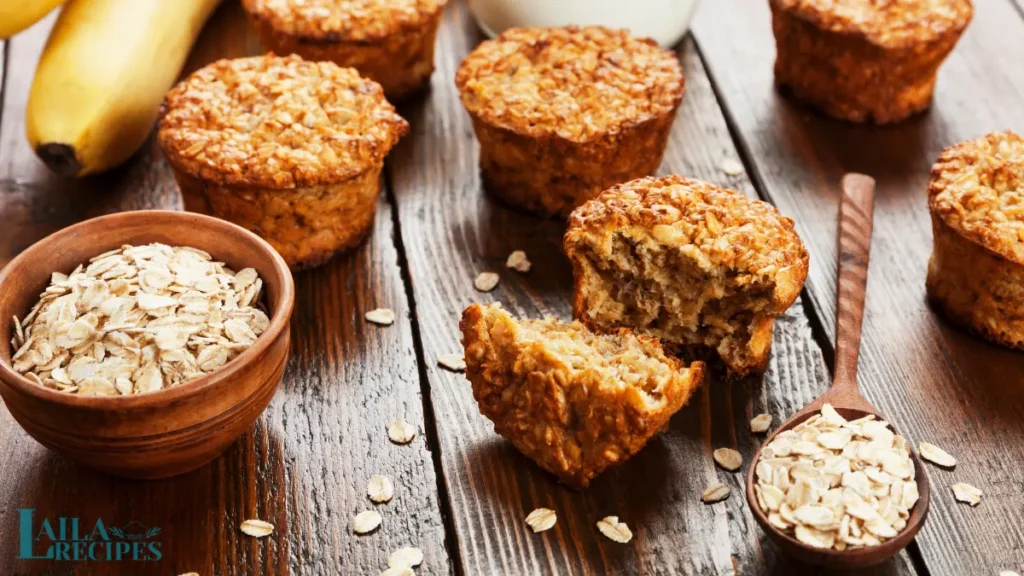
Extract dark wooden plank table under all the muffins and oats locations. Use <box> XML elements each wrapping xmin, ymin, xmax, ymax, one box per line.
<box><xmin>0</xmin><ymin>0</ymin><xmax>1024</xmax><ymax>576</ymax></box>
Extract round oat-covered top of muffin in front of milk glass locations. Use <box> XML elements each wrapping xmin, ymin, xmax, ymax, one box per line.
<box><xmin>456</xmin><ymin>26</ymin><xmax>683</xmax><ymax>142</ymax></box>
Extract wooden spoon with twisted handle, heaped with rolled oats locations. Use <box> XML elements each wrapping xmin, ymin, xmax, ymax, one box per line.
<box><xmin>746</xmin><ymin>174</ymin><xmax>930</xmax><ymax>568</ymax></box>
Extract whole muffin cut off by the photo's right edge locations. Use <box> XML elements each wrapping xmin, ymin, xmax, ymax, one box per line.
<box><xmin>926</xmin><ymin>132</ymin><xmax>1024</xmax><ymax>349</ymax></box>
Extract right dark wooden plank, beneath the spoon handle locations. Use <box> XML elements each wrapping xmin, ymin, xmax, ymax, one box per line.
<box><xmin>695</xmin><ymin>0</ymin><xmax>1024</xmax><ymax>575</ymax></box>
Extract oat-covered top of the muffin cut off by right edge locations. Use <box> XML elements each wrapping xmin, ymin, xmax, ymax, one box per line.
<box><xmin>928</xmin><ymin>131</ymin><xmax>1024</xmax><ymax>263</ymax></box>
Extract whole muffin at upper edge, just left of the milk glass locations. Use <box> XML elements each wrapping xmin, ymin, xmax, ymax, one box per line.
<box><xmin>242</xmin><ymin>0</ymin><xmax>446</xmax><ymax>101</ymax></box>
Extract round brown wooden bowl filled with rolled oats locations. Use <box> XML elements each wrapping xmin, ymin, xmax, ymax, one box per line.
<box><xmin>0</xmin><ymin>210</ymin><xmax>295</xmax><ymax>479</ymax></box>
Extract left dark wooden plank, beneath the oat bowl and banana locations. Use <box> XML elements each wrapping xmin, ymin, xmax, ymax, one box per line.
<box><xmin>0</xmin><ymin>2</ymin><xmax>453</xmax><ymax>576</ymax></box>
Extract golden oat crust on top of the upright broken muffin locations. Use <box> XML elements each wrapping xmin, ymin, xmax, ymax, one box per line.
<box><xmin>565</xmin><ymin>175</ymin><xmax>809</xmax><ymax>291</ymax></box>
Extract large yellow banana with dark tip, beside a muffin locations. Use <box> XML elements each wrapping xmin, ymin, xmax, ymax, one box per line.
<box><xmin>25</xmin><ymin>0</ymin><xmax>220</xmax><ymax>176</ymax></box>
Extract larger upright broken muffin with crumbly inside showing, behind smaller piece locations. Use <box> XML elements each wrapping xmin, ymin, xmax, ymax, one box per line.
<box><xmin>564</xmin><ymin>175</ymin><xmax>809</xmax><ymax>375</ymax></box>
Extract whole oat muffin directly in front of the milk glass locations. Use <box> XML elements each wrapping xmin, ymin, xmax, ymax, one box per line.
<box><xmin>456</xmin><ymin>27</ymin><xmax>683</xmax><ymax>217</ymax></box>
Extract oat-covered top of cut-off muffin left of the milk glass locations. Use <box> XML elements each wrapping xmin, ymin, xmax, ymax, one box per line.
<box><xmin>242</xmin><ymin>0</ymin><xmax>447</xmax><ymax>42</ymax></box>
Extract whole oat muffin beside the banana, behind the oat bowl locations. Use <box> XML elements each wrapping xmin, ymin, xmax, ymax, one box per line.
<box><xmin>157</xmin><ymin>54</ymin><xmax>409</xmax><ymax>269</ymax></box>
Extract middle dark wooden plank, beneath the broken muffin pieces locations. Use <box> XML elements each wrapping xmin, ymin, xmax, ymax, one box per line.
<box><xmin>390</xmin><ymin>2</ymin><xmax>912</xmax><ymax>574</ymax></box>
